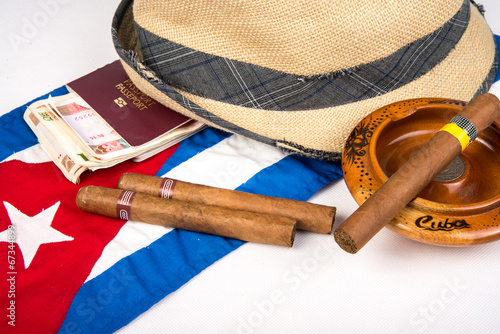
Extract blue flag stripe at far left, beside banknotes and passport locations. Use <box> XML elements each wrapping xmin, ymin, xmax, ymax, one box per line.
<box><xmin>0</xmin><ymin>86</ymin><xmax>68</xmax><ymax>161</ymax></box>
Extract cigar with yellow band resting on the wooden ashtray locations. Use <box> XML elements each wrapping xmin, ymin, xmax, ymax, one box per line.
<box><xmin>334</xmin><ymin>93</ymin><xmax>500</xmax><ymax>254</ymax></box>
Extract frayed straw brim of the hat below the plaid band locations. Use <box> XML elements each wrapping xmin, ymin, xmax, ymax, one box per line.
<box><xmin>114</xmin><ymin>1</ymin><xmax>498</xmax><ymax>160</ymax></box>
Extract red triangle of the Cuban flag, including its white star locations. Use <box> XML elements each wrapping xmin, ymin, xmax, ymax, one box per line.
<box><xmin>0</xmin><ymin>145</ymin><xmax>178</xmax><ymax>333</ymax></box>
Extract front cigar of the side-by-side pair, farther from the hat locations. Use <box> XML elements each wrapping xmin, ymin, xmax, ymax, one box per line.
<box><xmin>76</xmin><ymin>186</ymin><xmax>296</xmax><ymax>247</ymax></box>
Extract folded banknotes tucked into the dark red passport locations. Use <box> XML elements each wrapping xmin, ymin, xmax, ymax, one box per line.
<box><xmin>24</xmin><ymin>92</ymin><xmax>204</xmax><ymax>183</ymax></box>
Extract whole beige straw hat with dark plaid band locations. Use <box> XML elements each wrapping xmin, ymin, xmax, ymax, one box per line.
<box><xmin>113</xmin><ymin>0</ymin><xmax>497</xmax><ymax>160</ymax></box>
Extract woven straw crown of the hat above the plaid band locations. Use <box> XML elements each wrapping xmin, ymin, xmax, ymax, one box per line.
<box><xmin>134</xmin><ymin>0</ymin><xmax>463</xmax><ymax>75</ymax></box>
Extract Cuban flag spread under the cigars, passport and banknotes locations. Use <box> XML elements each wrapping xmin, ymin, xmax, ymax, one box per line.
<box><xmin>0</xmin><ymin>87</ymin><xmax>342</xmax><ymax>333</ymax></box>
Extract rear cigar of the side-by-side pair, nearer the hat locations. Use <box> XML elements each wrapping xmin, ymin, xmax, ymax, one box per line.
<box><xmin>118</xmin><ymin>173</ymin><xmax>336</xmax><ymax>234</ymax></box>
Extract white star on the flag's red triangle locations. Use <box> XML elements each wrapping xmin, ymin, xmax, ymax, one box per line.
<box><xmin>0</xmin><ymin>202</ymin><xmax>74</xmax><ymax>269</ymax></box>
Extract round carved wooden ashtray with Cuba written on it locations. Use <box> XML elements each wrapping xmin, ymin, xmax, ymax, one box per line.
<box><xmin>342</xmin><ymin>98</ymin><xmax>500</xmax><ymax>246</ymax></box>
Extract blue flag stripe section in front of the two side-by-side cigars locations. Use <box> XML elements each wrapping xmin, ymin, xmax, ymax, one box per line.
<box><xmin>59</xmin><ymin>230</ymin><xmax>243</xmax><ymax>333</ymax></box>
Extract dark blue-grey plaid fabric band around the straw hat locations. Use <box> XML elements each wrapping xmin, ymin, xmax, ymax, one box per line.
<box><xmin>132</xmin><ymin>1</ymin><xmax>470</xmax><ymax>111</ymax></box>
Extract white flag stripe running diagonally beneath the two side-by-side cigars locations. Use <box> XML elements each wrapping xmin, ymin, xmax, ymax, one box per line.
<box><xmin>86</xmin><ymin>135</ymin><xmax>287</xmax><ymax>282</ymax></box>
